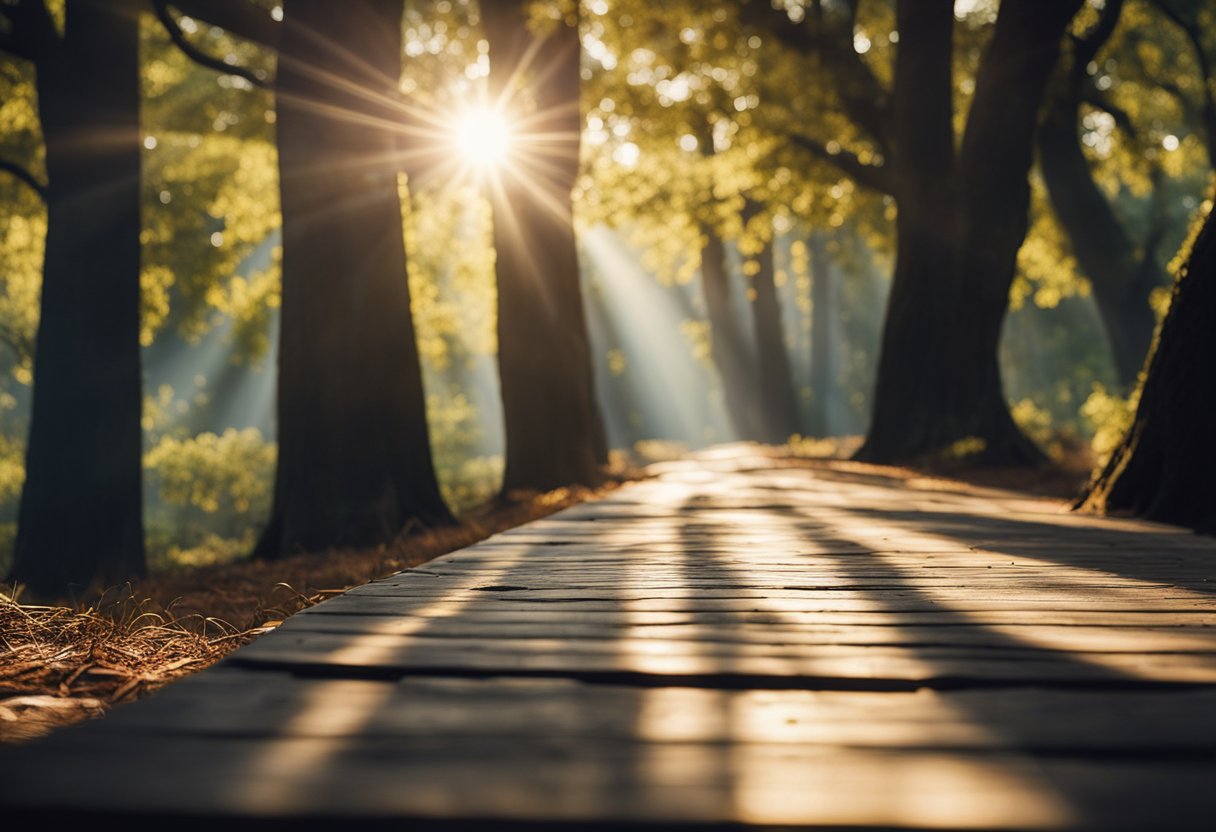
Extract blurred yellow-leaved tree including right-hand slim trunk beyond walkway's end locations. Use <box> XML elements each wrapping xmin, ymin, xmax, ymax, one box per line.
<box><xmin>581</xmin><ymin>0</ymin><xmax>838</xmax><ymax>442</ymax></box>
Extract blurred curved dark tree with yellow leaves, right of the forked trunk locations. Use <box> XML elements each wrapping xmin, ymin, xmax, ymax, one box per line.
<box><xmin>1038</xmin><ymin>0</ymin><xmax>1216</xmax><ymax>389</ymax></box>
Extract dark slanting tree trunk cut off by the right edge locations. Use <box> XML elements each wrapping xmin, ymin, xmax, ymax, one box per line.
<box><xmin>1082</xmin><ymin>199</ymin><xmax>1216</xmax><ymax>533</ymax></box>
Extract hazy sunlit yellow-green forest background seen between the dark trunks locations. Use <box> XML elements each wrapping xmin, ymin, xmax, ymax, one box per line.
<box><xmin>0</xmin><ymin>0</ymin><xmax>1216</xmax><ymax>572</ymax></box>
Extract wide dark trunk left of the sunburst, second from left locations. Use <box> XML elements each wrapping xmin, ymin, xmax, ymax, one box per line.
<box><xmin>255</xmin><ymin>0</ymin><xmax>450</xmax><ymax>558</ymax></box>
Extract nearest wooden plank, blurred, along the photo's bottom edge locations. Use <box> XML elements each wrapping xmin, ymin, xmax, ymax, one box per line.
<box><xmin>4</xmin><ymin>735</ymin><xmax>1216</xmax><ymax>830</ymax></box>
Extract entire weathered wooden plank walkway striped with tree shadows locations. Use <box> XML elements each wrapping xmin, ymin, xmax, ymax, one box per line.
<box><xmin>0</xmin><ymin>449</ymin><xmax>1216</xmax><ymax>831</ymax></box>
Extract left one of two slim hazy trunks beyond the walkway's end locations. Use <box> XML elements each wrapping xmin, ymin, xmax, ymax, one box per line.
<box><xmin>700</xmin><ymin>227</ymin><xmax>761</xmax><ymax>439</ymax></box>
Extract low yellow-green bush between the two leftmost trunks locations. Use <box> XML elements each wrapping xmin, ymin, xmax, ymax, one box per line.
<box><xmin>143</xmin><ymin>428</ymin><xmax>275</xmax><ymax>516</ymax></box>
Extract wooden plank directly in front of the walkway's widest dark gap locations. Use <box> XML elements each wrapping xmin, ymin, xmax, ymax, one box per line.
<box><xmin>76</xmin><ymin>668</ymin><xmax>1216</xmax><ymax>759</ymax></box>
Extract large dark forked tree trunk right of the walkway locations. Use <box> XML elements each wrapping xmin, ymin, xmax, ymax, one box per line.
<box><xmin>858</xmin><ymin>0</ymin><xmax>1081</xmax><ymax>465</ymax></box>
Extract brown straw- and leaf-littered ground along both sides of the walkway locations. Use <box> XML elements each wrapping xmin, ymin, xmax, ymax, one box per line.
<box><xmin>0</xmin><ymin>442</ymin><xmax>1090</xmax><ymax>742</ymax></box>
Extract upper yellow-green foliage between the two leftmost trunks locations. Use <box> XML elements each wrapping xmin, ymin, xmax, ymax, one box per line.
<box><xmin>140</xmin><ymin>18</ymin><xmax>280</xmax><ymax>359</ymax></box>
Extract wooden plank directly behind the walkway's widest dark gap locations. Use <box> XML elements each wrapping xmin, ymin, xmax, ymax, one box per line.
<box><xmin>227</xmin><ymin>631</ymin><xmax>1216</xmax><ymax>686</ymax></box>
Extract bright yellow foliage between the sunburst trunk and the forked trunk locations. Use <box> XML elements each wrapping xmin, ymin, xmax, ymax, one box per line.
<box><xmin>575</xmin><ymin>0</ymin><xmax>894</xmax><ymax>283</ymax></box>
